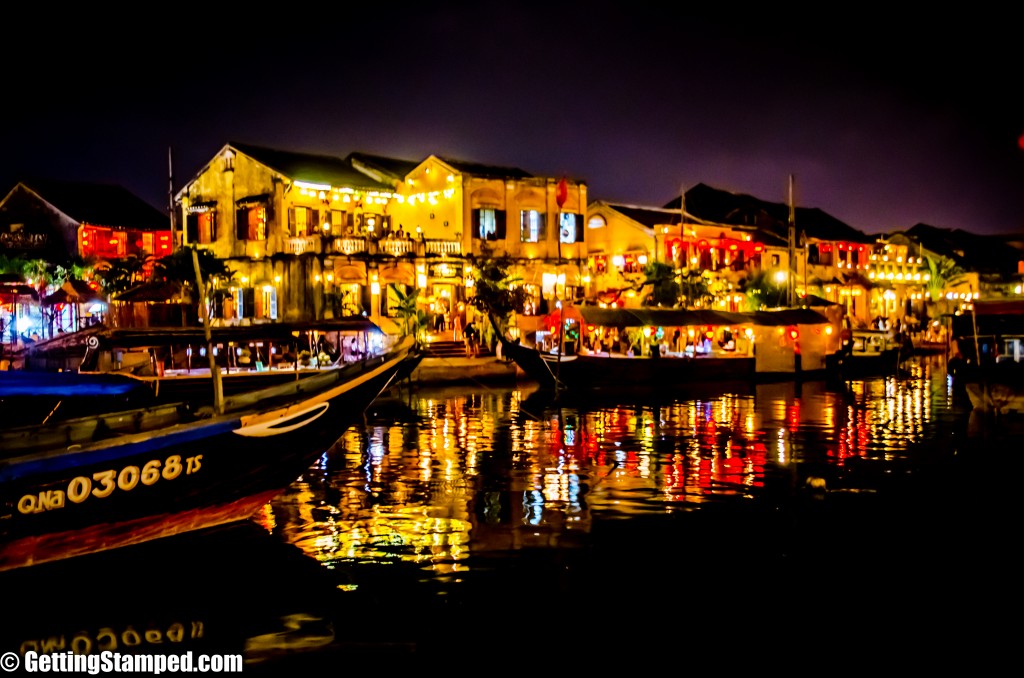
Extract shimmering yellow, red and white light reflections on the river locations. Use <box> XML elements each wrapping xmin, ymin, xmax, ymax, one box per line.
<box><xmin>261</xmin><ymin>359</ymin><xmax>965</xmax><ymax>583</ymax></box>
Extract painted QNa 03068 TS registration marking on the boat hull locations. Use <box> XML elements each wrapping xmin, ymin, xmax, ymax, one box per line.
<box><xmin>17</xmin><ymin>455</ymin><xmax>203</xmax><ymax>515</ymax></box>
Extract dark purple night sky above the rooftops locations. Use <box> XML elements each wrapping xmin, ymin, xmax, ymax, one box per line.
<box><xmin>0</xmin><ymin>2</ymin><xmax>1024</xmax><ymax>234</ymax></box>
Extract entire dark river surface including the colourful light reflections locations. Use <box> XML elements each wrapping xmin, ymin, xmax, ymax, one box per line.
<box><xmin>0</xmin><ymin>356</ymin><xmax>1021</xmax><ymax>675</ymax></box>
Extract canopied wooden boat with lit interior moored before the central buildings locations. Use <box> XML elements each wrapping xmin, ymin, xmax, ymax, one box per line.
<box><xmin>501</xmin><ymin>305</ymin><xmax>839</xmax><ymax>392</ymax></box>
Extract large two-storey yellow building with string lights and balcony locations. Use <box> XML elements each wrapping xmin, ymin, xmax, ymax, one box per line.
<box><xmin>175</xmin><ymin>143</ymin><xmax>587</xmax><ymax>333</ymax></box>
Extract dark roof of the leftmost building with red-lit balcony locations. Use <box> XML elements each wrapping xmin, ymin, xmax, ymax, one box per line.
<box><xmin>15</xmin><ymin>178</ymin><xmax>171</xmax><ymax>230</ymax></box>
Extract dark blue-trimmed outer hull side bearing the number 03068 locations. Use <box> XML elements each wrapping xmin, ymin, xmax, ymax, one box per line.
<box><xmin>0</xmin><ymin>340</ymin><xmax>410</xmax><ymax>569</ymax></box>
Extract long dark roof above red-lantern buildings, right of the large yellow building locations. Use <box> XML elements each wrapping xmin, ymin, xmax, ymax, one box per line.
<box><xmin>665</xmin><ymin>183</ymin><xmax>876</xmax><ymax>243</ymax></box>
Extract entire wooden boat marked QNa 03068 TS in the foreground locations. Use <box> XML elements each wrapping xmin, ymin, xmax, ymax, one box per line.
<box><xmin>0</xmin><ymin>338</ymin><xmax>415</xmax><ymax>570</ymax></box>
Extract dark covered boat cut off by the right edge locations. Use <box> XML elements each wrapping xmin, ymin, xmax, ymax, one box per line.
<box><xmin>946</xmin><ymin>299</ymin><xmax>1024</xmax><ymax>415</ymax></box>
